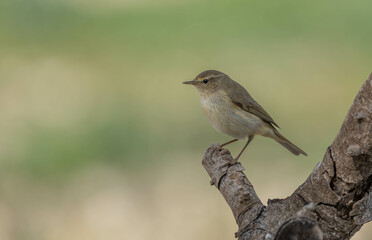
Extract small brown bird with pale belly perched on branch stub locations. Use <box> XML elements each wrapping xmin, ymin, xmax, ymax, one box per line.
<box><xmin>183</xmin><ymin>70</ymin><xmax>307</xmax><ymax>160</ymax></box>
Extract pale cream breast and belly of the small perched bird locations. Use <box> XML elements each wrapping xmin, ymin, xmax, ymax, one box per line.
<box><xmin>200</xmin><ymin>93</ymin><xmax>272</xmax><ymax>139</ymax></box>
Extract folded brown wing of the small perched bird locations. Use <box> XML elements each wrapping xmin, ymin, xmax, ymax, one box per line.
<box><xmin>227</xmin><ymin>81</ymin><xmax>279</xmax><ymax>128</ymax></box>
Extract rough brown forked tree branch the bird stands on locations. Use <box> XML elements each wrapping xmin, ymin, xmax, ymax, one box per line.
<box><xmin>202</xmin><ymin>74</ymin><xmax>372</xmax><ymax>240</ymax></box>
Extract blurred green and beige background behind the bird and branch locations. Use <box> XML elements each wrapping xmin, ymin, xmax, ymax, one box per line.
<box><xmin>0</xmin><ymin>0</ymin><xmax>372</xmax><ymax>240</ymax></box>
